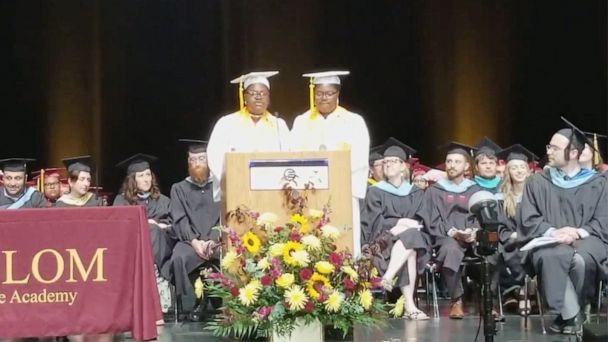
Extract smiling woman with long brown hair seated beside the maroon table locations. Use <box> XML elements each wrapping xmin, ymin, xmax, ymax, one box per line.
<box><xmin>113</xmin><ymin>153</ymin><xmax>175</xmax><ymax>313</ymax></box>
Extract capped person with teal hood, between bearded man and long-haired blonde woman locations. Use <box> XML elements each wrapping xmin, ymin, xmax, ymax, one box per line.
<box><xmin>473</xmin><ymin>137</ymin><xmax>501</xmax><ymax>194</ymax></box>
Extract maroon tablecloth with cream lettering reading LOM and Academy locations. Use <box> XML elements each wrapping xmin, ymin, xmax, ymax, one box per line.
<box><xmin>0</xmin><ymin>206</ymin><xmax>162</xmax><ymax>340</ymax></box>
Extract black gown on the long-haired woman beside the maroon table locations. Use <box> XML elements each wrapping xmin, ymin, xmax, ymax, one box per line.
<box><xmin>113</xmin><ymin>194</ymin><xmax>175</xmax><ymax>270</ymax></box>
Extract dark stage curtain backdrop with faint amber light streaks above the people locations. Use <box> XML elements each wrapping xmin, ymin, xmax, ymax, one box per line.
<box><xmin>0</xmin><ymin>0</ymin><xmax>608</xmax><ymax>192</ymax></box>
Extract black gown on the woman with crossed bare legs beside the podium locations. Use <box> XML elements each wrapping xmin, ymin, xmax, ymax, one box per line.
<box><xmin>361</xmin><ymin>186</ymin><xmax>430</xmax><ymax>287</ymax></box>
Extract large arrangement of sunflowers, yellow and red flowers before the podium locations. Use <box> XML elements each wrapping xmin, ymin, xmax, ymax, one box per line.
<box><xmin>205</xmin><ymin>208</ymin><xmax>385</xmax><ymax>339</ymax></box>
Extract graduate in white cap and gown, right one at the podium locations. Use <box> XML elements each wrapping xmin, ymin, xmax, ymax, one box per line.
<box><xmin>290</xmin><ymin>71</ymin><xmax>369</xmax><ymax>257</ymax></box>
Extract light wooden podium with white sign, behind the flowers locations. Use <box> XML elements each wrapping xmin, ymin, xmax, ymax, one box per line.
<box><xmin>222</xmin><ymin>151</ymin><xmax>353</xmax><ymax>252</ymax></box>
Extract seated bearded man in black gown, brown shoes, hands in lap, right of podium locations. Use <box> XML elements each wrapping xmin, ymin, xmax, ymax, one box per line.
<box><xmin>420</xmin><ymin>142</ymin><xmax>481</xmax><ymax>319</ymax></box>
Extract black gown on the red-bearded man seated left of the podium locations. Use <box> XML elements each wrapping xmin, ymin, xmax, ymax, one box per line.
<box><xmin>161</xmin><ymin>180</ymin><xmax>220</xmax><ymax>295</ymax></box>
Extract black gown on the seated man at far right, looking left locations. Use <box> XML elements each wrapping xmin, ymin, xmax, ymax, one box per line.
<box><xmin>517</xmin><ymin>170</ymin><xmax>608</xmax><ymax>309</ymax></box>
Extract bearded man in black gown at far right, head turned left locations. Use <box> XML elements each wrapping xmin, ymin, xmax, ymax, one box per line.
<box><xmin>517</xmin><ymin>119</ymin><xmax>608</xmax><ymax>334</ymax></box>
